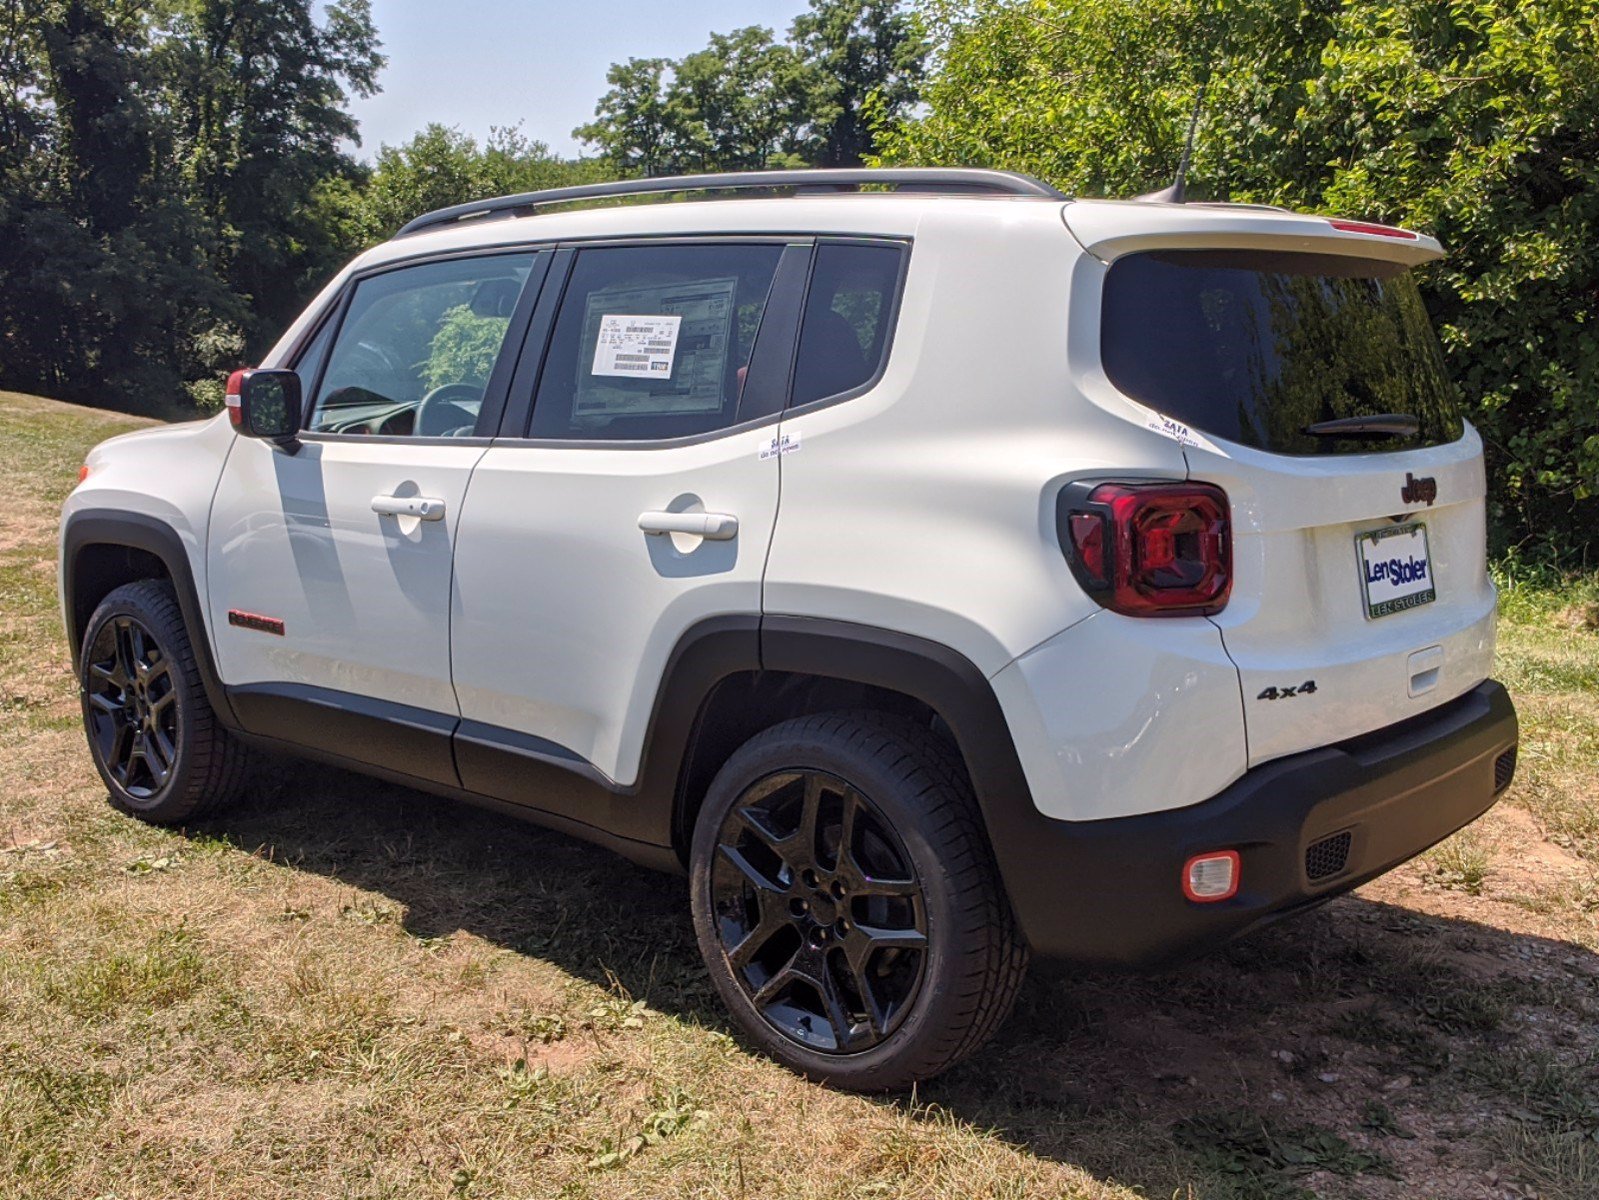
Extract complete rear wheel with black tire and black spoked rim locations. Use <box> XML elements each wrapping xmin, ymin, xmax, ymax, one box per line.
<box><xmin>689</xmin><ymin>714</ymin><xmax>1028</xmax><ymax>1091</ymax></box>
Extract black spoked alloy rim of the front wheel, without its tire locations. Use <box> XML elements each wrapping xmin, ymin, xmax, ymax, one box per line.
<box><xmin>85</xmin><ymin>614</ymin><xmax>181</xmax><ymax>800</ymax></box>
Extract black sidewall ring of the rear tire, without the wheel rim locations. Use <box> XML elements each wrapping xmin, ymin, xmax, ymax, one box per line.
<box><xmin>689</xmin><ymin>726</ymin><xmax>991</xmax><ymax>1091</ymax></box>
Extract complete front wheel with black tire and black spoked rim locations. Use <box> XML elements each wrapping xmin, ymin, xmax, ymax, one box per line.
<box><xmin>78</xmin><ymin>579</ymin><xmax>248</xmax><ymax>826</ymax></box>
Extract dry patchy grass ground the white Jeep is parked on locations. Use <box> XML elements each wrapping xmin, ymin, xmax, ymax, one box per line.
<box><xmin>0</xmin><ymin>394</ymin><xmax>1599</xmax><ymax>1200</ymax></box>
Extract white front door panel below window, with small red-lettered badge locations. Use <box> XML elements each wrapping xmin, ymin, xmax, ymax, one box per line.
<box><xmin>206</xmin><ymin>440</ymin><xmax>484</xmax><ymax>714</ymax></box>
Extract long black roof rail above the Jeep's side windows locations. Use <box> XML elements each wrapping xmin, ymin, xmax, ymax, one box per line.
<box><xmin>395</xmin><ymin>166</ymin><xmax>1067</xmax><ymax>237</ymax></box>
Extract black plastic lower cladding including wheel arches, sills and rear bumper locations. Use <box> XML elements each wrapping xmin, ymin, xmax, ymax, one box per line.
<box><xmin>64</xmin><ymin>510</ymin><xmax>1517</xmax><ymax>966</ymax></box>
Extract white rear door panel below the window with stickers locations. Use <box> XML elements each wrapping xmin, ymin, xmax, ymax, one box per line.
<box><xmin>451</xmin><ymin>429</ymin><xmax>777</xmax><ymax>787</ymax></box>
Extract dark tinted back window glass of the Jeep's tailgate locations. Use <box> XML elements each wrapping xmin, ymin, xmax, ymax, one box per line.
<box><xmin>1100</xmin><ymin>250</ymin><xmax>1461</xmax><ymax>454</ymax></box>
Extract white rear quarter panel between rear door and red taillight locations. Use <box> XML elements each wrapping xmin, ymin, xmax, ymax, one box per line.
<box><xmin>766</xmin><ymin>213</ymin><xmax>1246</xmax><ymax>821</ymax></box>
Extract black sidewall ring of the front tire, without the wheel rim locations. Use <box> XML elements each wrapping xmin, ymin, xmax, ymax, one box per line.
<box><xmin>78</xmin><ymin>582</ymin><xmax>195</xmax><ymax>821</ymax></box>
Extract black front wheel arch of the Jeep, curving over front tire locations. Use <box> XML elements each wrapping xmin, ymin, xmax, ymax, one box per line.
<box><xmin>61</xmin><ymin>509</ymin><xmax>237</xmax><ymax>728</ymax></box>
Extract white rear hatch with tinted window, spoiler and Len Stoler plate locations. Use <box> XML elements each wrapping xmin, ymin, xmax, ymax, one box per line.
<box><xmin>1067</xmin><ymin>203</ymin><xmax>1495</xmax><ymax>765</ymax></box>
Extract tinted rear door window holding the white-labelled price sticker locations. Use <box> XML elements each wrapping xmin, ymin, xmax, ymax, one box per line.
<box><xmin>531</xmin><ymin>243</ymin><xmax>784</xmax><ymax>442</ymax></box>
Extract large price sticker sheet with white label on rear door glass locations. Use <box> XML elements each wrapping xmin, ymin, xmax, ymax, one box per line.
<box><xmin>572</xmin><ymin>275</ymin><xmax>739</xmax><ymax>422</ymax></box>
